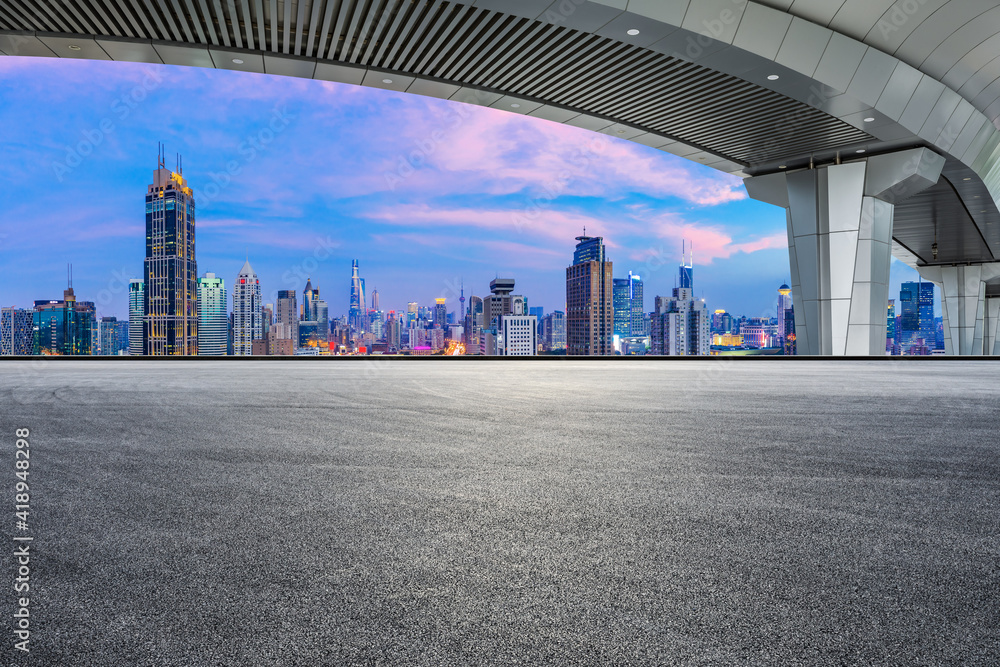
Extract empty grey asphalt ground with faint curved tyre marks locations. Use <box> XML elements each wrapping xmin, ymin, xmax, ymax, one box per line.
<box><xmin>0</xmin><ymin>360</ymin><xmax>1000</xmax><ymax>666</ymax></box>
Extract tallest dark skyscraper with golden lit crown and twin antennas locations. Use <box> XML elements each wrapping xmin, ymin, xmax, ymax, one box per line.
<box><xmin>143</xmin><ymin>146</ymin><xmax>198</xmax><ymax>355</ymax></box>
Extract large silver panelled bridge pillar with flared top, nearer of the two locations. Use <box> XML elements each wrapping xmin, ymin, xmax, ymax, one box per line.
<box><xmin>744</xmin><ymin>148</ymin><xmax>944</xmax><ymax>356</ymax></box>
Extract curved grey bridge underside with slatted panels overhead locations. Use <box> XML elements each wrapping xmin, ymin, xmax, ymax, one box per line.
<box><xmin>0</xmin><ymin>0</ymin><xmax>1000</xmax><ymax>264</ymax></box>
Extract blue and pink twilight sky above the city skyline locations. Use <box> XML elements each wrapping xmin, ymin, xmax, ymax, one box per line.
<box><xmin>0</xmin><ymin>57</ymin><xmax>916</xmax><ymax>317</ymax></box>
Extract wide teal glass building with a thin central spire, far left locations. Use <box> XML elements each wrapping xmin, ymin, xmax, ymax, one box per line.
<box><xmin>31</xmin><ymin>281</ymin><xmax>97</xmax><ymax>355</ymax></box>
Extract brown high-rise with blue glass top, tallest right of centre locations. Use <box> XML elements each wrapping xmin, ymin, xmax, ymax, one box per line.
<box><xmin>566</xmin><ymin>229</ymin><xmax>614</xmax><ymax>355</ymax></box>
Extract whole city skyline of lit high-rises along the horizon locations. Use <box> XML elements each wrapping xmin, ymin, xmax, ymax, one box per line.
<box><xmin>0</xmin><ymin>153</ymin><xmax>944</xmax><ymax>356</ymax></box>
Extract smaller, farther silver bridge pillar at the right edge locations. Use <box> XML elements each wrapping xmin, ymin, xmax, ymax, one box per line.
<box><xmin>917</xmin><ymin>262</ymin><xmax>1000</xmax><ymax>355</ymax></box>
